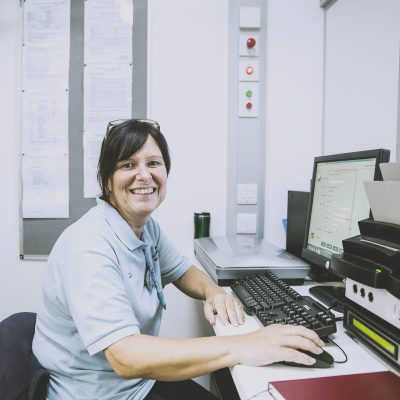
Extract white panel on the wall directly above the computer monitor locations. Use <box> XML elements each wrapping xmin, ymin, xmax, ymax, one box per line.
<box><xmin>323</xmin><ymin>0</ymin><xmax>400</xmax><ymax>156</ymax></box>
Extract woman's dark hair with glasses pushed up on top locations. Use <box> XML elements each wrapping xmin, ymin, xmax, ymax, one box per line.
<box><xmin>97</xmin><ymin>119</ymin><xmax>171</xmax><ymax>201</ymax></box>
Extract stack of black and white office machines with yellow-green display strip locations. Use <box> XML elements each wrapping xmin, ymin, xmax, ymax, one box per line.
<box><xmin>331</xmin><ymin>218</ymin><xmax>400</xmax><ymax>370</ymax></box>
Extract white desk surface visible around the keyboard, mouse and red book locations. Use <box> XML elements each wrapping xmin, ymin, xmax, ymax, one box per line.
<box><xmin>214</xmin><ymin>284</ymin><xmax>389</xmax><ymax>400</ymax></box>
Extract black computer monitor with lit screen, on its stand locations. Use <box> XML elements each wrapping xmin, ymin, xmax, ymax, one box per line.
<box><xmin>302</xmin><ymin>149</ymin><xmax>390</xmax><ymax>311</ymax></box>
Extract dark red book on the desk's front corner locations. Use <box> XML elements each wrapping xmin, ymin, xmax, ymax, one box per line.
<box><xmin>268</xmin><ymin>371</ymin><xmax>400</xmax><ymax>400</ymax></box>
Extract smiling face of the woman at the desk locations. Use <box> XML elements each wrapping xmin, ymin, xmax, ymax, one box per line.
<box><xmin>108</xmin><ymin>135</ymin><xmax>167</xmax><ymax>228</ymax></box>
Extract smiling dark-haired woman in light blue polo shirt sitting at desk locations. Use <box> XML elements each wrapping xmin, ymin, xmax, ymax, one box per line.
<box><xmin>33</xmin><ymin>119</ymin><xmax>323</xmax><ymax>400</ymax></box>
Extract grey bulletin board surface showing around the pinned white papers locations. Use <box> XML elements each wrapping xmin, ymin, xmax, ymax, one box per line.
<box><xmin>20</xmin><ymin>0</ymin><xmax>148</xmax><ymax>260</ymax></box>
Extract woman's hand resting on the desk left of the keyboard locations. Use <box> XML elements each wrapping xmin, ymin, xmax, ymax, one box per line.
<box><xmin>204</xmin><ymin>285</ymin><xmax>245</xmax><ymax>326</ymax></box>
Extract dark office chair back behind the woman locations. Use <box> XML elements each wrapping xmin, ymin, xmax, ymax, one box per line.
<box><xmin>0</xmin><ymin>312</ymin><xmax>49</xmax><ymax>400</ymax></box>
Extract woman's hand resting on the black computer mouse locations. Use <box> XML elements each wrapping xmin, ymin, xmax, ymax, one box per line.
<box><xmin>232</xmin><ymin>324</ymin><xmax>324</xmax><ymax>366</ymax></box>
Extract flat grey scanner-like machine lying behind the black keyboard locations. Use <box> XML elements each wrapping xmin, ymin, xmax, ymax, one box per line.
<box><xmin>194</xmin><ymin>235</ymin><xmax>310</xmax><ymax>286</ymax></box>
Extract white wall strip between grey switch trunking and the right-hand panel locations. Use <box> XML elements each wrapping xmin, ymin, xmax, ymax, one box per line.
<box><xmin>264</xmin><ymin>0</ymin><xmax>323</xmax><ymax>247</ymax></box>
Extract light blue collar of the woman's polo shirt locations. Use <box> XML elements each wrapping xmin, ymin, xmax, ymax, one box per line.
<box><xmin>96</xmin><ymin>198</ymin><xmax>151</xmax><ymax>251</ymax></box>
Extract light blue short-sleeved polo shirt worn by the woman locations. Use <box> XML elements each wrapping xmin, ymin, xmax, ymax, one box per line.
<box><xmin>33</xmin><ymin>199</ymin><xmax>191</xmax><ymax>400</ymax></box>
